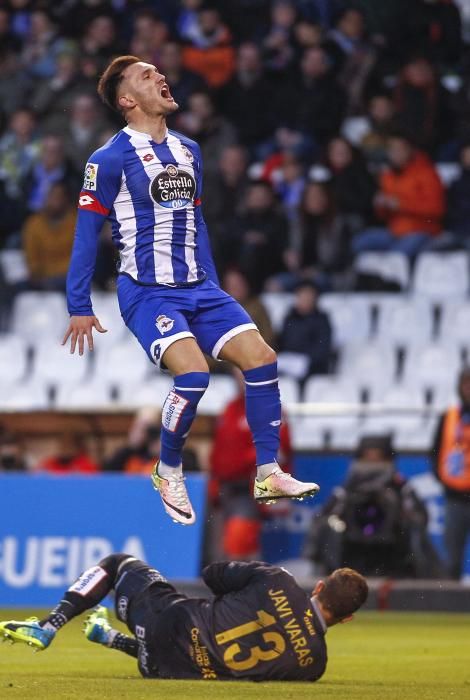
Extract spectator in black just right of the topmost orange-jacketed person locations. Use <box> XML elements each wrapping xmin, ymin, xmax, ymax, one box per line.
<box><xmin>218</xmin><ymin>42</ymin><xmax>275</xmax><ymax>149</ymax></box>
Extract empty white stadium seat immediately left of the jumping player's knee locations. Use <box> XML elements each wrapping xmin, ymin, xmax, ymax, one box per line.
<box><xmin>94</xmin><ymin>337</ymin><xmax>150</xmax><ymax>386</ymax></box>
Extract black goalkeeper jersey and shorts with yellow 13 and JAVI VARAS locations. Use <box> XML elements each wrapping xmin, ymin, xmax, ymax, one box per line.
<box><xmin>144</xmin><ymin>562</ymin><xmax>327</xmax><ymax>681</ymax></box>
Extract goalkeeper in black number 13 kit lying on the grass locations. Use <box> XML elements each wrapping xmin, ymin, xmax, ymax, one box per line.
<box><xmin>0</xmin><ymin>554</ymin><xmax>368</xmax><ymax>681</ymax></box>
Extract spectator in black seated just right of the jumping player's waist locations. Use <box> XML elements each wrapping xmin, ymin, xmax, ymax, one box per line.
<box><xmin>227</xmin><ymin>180</ymin><xmax>288</xmax><ymax>293</ymax></box>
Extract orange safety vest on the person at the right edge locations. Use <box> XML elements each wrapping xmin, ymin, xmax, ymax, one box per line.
<box><xmin>438</xmin><ymin>406</ymin><xmax>470</xmax><ymax>491</ymax></box>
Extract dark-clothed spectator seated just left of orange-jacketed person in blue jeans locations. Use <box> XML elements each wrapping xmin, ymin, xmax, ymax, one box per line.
<box><xmin>274</xmin><ymin>182</ymin><xmax>352</xmax><ymax>291</ymax></box>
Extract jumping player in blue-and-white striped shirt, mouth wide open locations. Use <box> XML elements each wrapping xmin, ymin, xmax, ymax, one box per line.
<box><xmin>63</xmin><ymin>56</ymin><xmax>319</xmax><ymax>525</ymax></box>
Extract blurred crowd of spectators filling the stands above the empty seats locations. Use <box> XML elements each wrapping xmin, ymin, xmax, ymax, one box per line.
<box><xmin>0</xmin><ymin>0</ymin><xmax>470</xmax><ymax>293</ymax></box>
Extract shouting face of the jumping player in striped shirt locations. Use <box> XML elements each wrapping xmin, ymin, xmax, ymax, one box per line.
<box><xmin>119</xmin><ymin>61</ymin><xmax>178</xmax><ymax>116</ymax></box>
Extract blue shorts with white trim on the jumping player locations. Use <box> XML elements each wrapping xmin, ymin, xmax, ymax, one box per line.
<box><xmin>117</xmin><ymin>275</ymin><xmax>257</xmax><ymax>368</ymax></box>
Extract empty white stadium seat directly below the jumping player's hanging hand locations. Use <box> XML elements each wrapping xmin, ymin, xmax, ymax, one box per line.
<box><xmin>32</xmin><ymin>339</ymin><xmax>90</xmax><ymax>387</ymax></box>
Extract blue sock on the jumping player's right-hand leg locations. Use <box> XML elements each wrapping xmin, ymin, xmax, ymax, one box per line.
<box><xmin>243</xmin><ymin>362</ymin><xmax>281</xmax><ymax>466</ymax></box>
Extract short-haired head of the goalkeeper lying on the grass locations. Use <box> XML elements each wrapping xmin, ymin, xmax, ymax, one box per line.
<box><xmin>317</xmin><ymin>568</ymin><xmax>369</xmax><ymax>621</ymax></box>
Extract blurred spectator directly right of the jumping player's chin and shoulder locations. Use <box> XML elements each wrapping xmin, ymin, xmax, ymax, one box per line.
<box><xmin>176</xmin><ymin>90</ymin><xmax>236</xmax><ymax>175</ymax></box>
